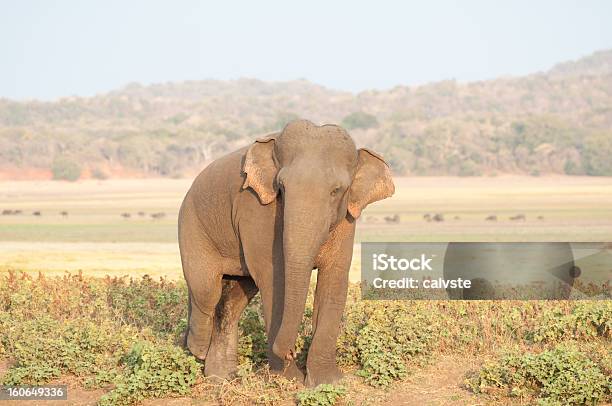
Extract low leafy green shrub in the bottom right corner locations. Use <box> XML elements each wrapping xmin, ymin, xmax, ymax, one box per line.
<box><xmin>466</xmin><ymin>345</ymin><xmax>612</xmax><ymax>405</ymax></box>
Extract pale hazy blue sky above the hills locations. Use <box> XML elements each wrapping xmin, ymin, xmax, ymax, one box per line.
<box><xmin>0</xmin><ymin>0</ymin><xmax>612</xmax><ymax>99</ymax></box>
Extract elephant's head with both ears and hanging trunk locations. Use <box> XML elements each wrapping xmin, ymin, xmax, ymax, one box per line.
<box><xmin>243</xmin><ymin>120</ymin><xmax>395</xmax><ymax>359</ymax></box>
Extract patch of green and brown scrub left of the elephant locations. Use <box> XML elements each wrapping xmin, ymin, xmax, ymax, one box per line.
<box><xmin>0</xmin><ymin>274</ymin><xmax>199</xmax><ymax>404</ymax></box>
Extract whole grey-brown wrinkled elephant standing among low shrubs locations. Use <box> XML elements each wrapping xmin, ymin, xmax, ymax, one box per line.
<box><xmin>179</xmin><ymin>120</ymin><xmax>394</xmax><ymax>386</ymax></box>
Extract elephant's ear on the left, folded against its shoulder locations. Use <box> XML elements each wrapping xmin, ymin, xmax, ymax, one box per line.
<box><xmin>242</xmin><ymin>134</ymin><xmax>278</xmax><ymax>204</ymax></box>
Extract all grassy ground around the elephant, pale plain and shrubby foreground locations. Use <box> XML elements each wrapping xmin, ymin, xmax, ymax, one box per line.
<box><xmin>0</xmin><ymin>176</ymin><xmax>612</xmax><ymax>405</ymax></box>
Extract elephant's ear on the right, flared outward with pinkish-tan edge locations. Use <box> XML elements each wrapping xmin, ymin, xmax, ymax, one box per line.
<box><xmin>348</xmin><ymin>148</ymin><xmax>395</xmax><ymax>219</ymax></box>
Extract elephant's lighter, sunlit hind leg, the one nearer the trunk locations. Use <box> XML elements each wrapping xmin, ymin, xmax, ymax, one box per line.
<box><xmin>204</xmin><ymin>277</ymin><xmax>258</xmax><ymax>379</ymax></box>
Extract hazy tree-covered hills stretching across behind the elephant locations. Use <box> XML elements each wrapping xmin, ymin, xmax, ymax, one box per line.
<box><xmin>0</xmin><ymin>50</ymin><xmax>612</xmax><ymax>178</ymax></box>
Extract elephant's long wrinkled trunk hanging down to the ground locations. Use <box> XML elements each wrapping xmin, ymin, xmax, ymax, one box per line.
<box><xmin>272</xmin><ymin>195</ymin><xmax>329</xmax><ymax>360</ymax></box>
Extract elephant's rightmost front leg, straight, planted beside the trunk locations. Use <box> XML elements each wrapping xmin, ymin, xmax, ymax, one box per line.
<box><xmin>305</xmin><ymin>251</ymin><xmax>352</xmax><ymax>387</ymax></box>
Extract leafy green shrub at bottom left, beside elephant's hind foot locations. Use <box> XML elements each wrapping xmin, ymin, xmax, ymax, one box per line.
<box><xmin>100</xmin><ymin>341</ymin><xmax>200</xmax><ymax>405</ymax></box>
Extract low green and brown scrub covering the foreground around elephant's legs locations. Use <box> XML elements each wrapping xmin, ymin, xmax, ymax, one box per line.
<box><xmin>0</xmin><ymin>273</ymin><xmax>612</xmax><ymax>404</ymax></box>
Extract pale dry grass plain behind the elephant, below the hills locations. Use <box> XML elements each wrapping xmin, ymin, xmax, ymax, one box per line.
<box><xmin>0</xmin><ymin>176</ymin><xmax>612</xmax><ymax>280</ymax></box>
